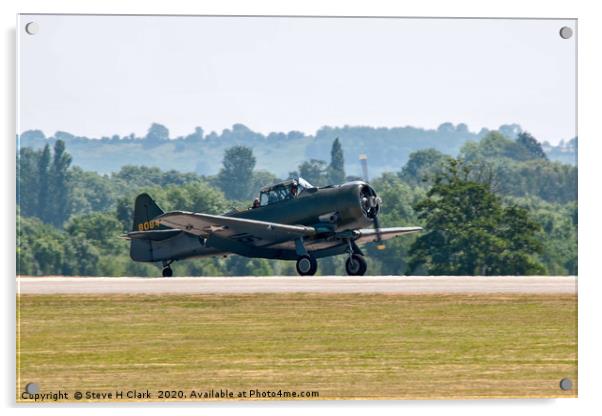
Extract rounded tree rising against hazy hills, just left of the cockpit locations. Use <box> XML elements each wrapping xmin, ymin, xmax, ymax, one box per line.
<box><xmin>217</xmin><ymin>146</ymin><xmax>256</xmax><ymax>200</ymax></box>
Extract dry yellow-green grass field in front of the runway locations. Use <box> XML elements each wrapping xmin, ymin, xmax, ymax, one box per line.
<box><xmin>17</xmin><ymin>294</ymin><xmax>577</xmax><ymax>400</ymax></box>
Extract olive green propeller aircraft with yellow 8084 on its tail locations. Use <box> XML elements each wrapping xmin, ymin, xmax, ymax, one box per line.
<box><xmin>124</xmin><ymin>178</ymin><xmax>422</xmax><ymax>277</ymax></box>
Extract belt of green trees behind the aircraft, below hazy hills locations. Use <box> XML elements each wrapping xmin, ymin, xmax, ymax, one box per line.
<box><xmin>17</xmin><ymin>132</ymin><xmax>577</xmax><ymax>276</ymax></box>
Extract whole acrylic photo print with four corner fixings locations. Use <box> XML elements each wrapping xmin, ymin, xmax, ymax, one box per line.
<box><xmin>16</xmin><ymin>15</ymin><xmax>577</xmax><ymax>403</ymax></box>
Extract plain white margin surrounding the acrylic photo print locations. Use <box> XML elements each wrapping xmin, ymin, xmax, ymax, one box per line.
<box><xmin>0</xmin><ymin>0</ymin><xmax>602</xmax><ymax>416</ymax></box>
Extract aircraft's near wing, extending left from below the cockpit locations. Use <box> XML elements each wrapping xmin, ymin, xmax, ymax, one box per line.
<box><xmin>156</xmin><ymin>211</ymin><xmax>316</xmax><ymax>245</ymax></box>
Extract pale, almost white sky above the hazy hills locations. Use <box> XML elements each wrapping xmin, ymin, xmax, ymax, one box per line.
<box><xmin>18</xmin><ymin>15</ymin><xmax>576</xmax><ymax>143</ymax></box>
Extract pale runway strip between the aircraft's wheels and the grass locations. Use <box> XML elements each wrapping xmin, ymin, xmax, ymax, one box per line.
<box><xmin>17</xmin><ymin>276</ymin><xmax>577</xmax><ymax>294</ymax></box>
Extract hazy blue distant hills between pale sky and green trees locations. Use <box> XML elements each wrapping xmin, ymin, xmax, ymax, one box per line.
<box><xmin>19</xmin><ymin>123</ymin><xmax>577</xmax><ymax>177</ymax></box>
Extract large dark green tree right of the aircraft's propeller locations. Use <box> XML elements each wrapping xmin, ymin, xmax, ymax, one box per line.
<box><xmin>410</xmin><ymin>160</ymin><xmax>545</xmax><ymax>275</ymax></box>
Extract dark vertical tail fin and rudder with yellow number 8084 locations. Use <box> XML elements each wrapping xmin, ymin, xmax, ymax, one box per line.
<box><xmin>130</xmin><ymin>194</ymin><xmax>167</xmax><ymax>261</ymax></box>
